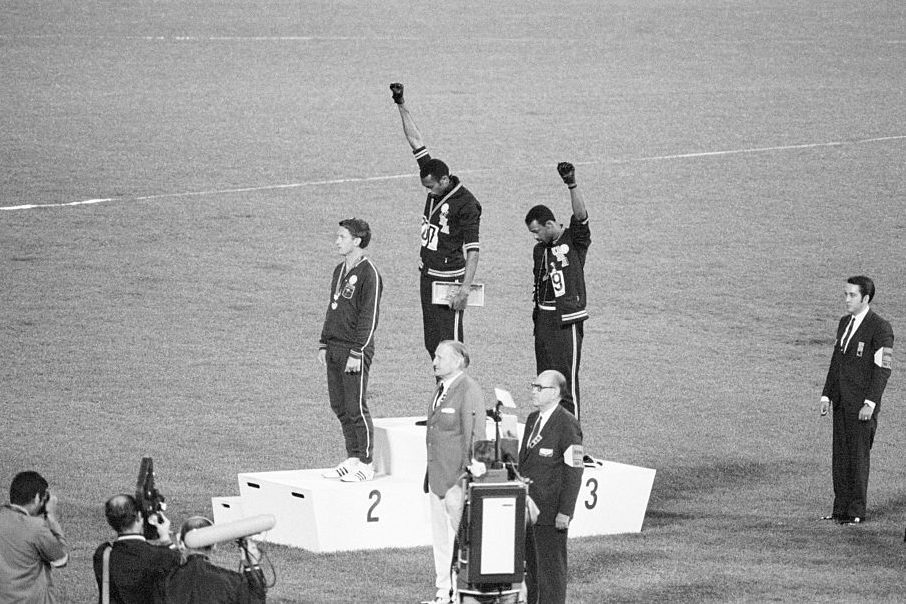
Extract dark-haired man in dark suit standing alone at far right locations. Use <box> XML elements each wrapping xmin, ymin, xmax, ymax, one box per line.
<box><xmin>821</xmin><ymin>276</ymin><xmax>893</xmax><ymax>525</ymax></box>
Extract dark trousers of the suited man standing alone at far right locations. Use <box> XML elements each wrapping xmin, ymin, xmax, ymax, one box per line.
<box><xmin>832</xmin><ymin>405</ymin><xmax>878</xmax><ymax>518</ymax></box>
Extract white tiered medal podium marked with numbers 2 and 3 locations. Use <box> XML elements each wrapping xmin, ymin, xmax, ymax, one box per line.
<box><xmin>211</xmin><ymin>417</ymin><xmax>655</xmax><ymax>552</ymax></box>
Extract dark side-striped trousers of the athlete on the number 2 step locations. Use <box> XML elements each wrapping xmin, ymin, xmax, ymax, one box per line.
<box><xmin>327</xmin><ymin>344</ymin><xmax>374</xmax><ymax>463</ymax></box>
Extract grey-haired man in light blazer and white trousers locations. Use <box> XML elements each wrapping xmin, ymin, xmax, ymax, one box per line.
<box><xmin>425</xmin><ymin>340</ymin><xmax>486</xmax><ymax>604</ymax></box>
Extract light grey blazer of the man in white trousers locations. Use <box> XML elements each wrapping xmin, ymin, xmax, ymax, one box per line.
<box><xmin>425</xmin><ymin>373</ymin><xmax>486</xmax><ymax>497</ymax></box>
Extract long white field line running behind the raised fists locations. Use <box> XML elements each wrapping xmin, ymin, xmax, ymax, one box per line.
<box><xmin>0</xmin><ymin>135</ymin><xmax>906</xmax><ymax>210</ymax></box>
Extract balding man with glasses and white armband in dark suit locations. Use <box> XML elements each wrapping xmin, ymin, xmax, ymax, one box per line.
<box><xmin>519</xmin><ymin>371</ymin><xmax>583</xmax><ymax>604</ymax></box>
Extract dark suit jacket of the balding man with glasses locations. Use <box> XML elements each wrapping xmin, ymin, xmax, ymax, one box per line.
<box><xmin>519</xmin><ymin>404</ymin><xmax>584</xmax><ymax>526</ymax></box>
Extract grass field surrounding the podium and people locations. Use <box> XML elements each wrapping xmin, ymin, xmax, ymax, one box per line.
<box><xmin>0</xmin><ymin>0</ymin><xmax>906</xmax><ymax>603</ymax></box>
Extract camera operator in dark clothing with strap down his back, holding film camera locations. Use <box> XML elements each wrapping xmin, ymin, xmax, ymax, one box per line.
<box><xmin>94</xmin><ymin>495</ymin><xmax>180</xmax><ymax>604</ymax></box>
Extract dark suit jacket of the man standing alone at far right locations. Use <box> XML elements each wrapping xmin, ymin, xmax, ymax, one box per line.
<box><xmin>821</xmin><ymin>309</ymin><xmax>893</xmax><ymax>417</ymax></box>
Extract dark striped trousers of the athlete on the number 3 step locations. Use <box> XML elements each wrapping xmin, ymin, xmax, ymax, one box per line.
<box><xmin>535</xmin><ymin>310</ymin><xmax>584</xmax><ymax>420</ymax></box>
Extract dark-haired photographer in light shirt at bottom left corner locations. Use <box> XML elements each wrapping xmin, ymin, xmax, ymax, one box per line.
<box><xmin>0</xmin><ymin>471</ymin><xmax>69</xmax><ymax>604</ymax></box>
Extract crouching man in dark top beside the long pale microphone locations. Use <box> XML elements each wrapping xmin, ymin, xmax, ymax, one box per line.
<box><xmin>155</xmin><ymin>516</ymin><xmax>266</xmax><ymax>604</ymax></box>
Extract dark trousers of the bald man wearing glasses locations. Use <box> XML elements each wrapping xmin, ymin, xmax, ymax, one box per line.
<box><xmin>525</xmin><ymin>524</ymin><xmax>569</xmax><ymax>604</ymax></box>
